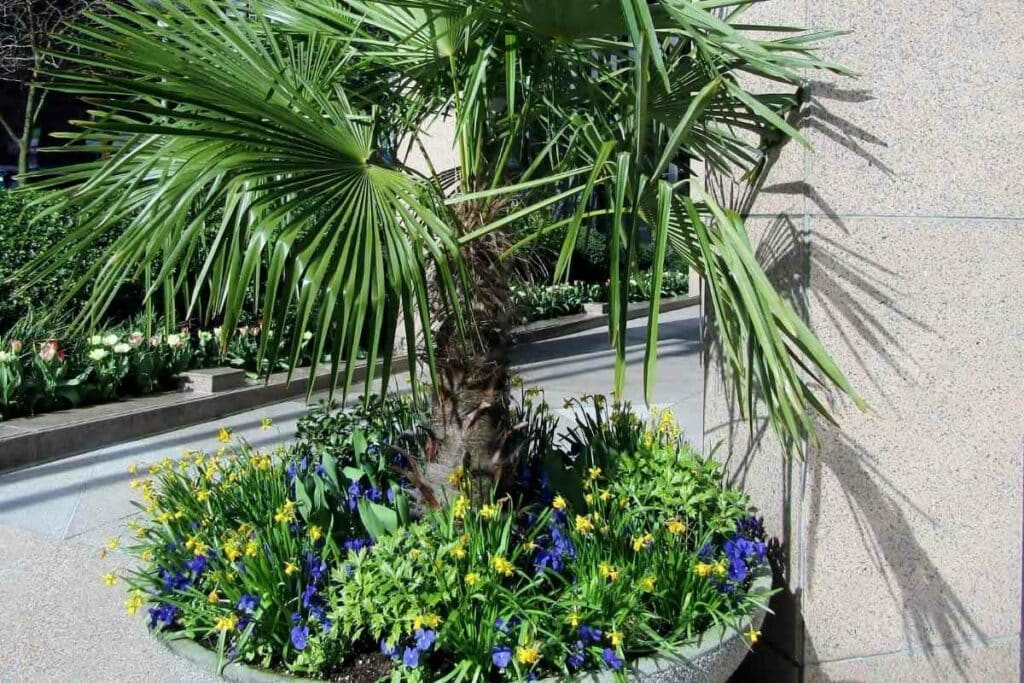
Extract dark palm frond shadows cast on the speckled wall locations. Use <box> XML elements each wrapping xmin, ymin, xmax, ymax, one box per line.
<box><xmin>705</xmin><ymin>83</ymin><xmax>986</xmax><ymax>681</ymax></box>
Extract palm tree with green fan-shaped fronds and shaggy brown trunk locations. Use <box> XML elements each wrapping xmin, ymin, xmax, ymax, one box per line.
<box><xmin>18</xmin><ymin>0</ymin><xmax>859</xmax><ymax>493</ymax></box>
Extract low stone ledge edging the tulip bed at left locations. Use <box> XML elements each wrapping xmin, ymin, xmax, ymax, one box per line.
<box><xmin>0</xmin><ymin>356</ymin><xmax>409</xmax><ymax>471</ymax></box>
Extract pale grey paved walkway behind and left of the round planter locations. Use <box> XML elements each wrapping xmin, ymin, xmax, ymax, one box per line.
<box><xmin>0</xmin><ymin>308</ymin><xmax>702</xmax><ymax>683</ymax></box>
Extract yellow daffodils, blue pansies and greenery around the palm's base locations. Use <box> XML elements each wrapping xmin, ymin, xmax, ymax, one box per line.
<box><xmin>106</xmin><ymin>397</ymin><xmax>766</xmax><ymax>681</ymax></box>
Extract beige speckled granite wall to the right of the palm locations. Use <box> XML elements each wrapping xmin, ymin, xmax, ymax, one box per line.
<box><xmin>705</xmin><ymin>0</ymin><xmax>1024</xmax><ymax>681</ymax></box>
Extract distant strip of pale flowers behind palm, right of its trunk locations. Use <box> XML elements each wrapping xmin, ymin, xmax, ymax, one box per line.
<box><xmin>512</xmin><ymin>270</ymin><xmax>689</xmax><ymax>325</ymax></box>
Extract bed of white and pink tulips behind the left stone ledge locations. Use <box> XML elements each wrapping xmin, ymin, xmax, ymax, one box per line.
<box><xmin>0</xmin><ymin>326</ymin><xmax>317</xmax><ymax>421</ymax></box>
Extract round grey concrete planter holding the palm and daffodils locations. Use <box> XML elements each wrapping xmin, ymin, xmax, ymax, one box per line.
<box><xmin>161</xmin><ymin>564</ymin><xmax>771</xmax><ymax>683</ymax></box>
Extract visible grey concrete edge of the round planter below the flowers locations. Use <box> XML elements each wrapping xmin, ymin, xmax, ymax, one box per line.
<box><xmin>158</xmin><ymin>561</ymin><xmax>772</xmax><ymax>683</ymax></box>
